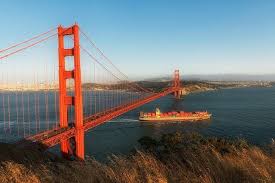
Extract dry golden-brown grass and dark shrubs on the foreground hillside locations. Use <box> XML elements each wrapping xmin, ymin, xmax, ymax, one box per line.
<box><xmin>0</xmin><ymin>133</ymin><xmax>275</xmax><ymax>183</ymax></box>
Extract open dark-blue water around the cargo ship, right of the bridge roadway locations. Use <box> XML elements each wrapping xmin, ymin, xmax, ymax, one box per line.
<box><xmin>85</xmin><ymin>87</ymin><xmax>275</xmax><ymax>159</ymax></box>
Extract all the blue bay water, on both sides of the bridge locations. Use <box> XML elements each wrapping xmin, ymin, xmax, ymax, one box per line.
<box><xmin>0</xmin><ymin>87</ymin><xmax>275</xmax><ymax>160</ymax></box>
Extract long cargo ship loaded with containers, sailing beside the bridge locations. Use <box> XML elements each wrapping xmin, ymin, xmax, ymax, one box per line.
<box><xmin>139</xmin><ymin>108</ymin><xmax>212</xmax><ymax>121</ymax></box>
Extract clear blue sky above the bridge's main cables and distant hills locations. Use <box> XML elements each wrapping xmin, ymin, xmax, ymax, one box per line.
<box><xmin>0</xmin><ymin>0</ymin><xmax>275</xmax><ymax>78</ymax></box>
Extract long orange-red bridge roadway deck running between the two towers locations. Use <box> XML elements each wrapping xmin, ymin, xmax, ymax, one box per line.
<box><xmin>22</xmin><ymin>87</ymin><xmax>180</xmax><ymax>147</ymax></box>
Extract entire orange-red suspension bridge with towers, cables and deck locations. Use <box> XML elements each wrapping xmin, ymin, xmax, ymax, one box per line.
<box><xmin>0</xmin><ymin>24</ymin><xmax>181</xmax><ymax>159</ymax></box>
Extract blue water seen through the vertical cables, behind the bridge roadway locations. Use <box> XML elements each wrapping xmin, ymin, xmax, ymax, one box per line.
<box><xmin>0</xmin><ymin>90</ymin><xmax>144</xmax><ymax>143</ymax></box>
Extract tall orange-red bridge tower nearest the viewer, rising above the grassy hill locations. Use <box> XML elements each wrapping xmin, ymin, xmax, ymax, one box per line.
<box><xmin>58</xmin><ymin>24</ymin><xmax>84</xmax><ymax>159</ymax></box>
